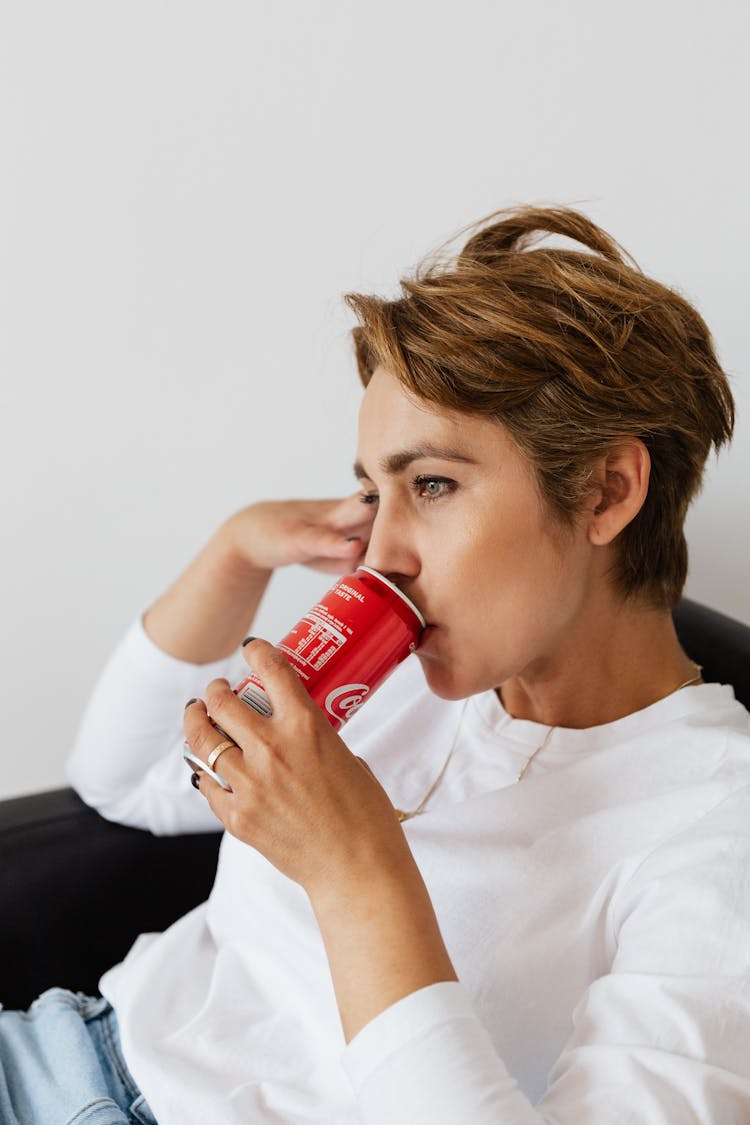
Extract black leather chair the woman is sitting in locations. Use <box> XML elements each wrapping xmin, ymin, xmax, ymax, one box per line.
<box><xmin>0</xmin><ymin>601</ymin><xmax>750</xmax><ymax>1008</ymax></box>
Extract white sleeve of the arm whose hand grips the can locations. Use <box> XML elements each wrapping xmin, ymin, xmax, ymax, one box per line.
<box><xmin>344</xmin><ymin>789</ymin><xmax>750</xmax><ymax>1125</ymax></box>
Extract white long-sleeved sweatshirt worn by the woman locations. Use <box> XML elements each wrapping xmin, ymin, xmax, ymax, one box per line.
<box><xmin>69</xmin><ymin>623</ymin><xmax>750</xmax><ymax>1125</ymax></box>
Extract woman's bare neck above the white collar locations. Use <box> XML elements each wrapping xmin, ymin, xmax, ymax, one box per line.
<box><xmin>497</xmin><ymin>602</ymin><xmax>699</xmax><ymax>729</ymax></box>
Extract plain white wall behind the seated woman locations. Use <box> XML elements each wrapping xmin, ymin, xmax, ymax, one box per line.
<box><xmin>0</xmin><ymin>0</ymin><xmax>750</xmax><ymax>797</ymax></box>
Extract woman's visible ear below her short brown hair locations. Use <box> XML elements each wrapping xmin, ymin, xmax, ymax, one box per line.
<box><xmin>587</xmin><ymin>438</ymin><xmax>651</xmax><ymax>547</ymax></box>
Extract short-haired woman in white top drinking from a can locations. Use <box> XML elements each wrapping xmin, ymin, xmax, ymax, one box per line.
<box><xmin>0</xmin><ymin>208</ymin><xmax>750</xmax><ymax>1125</ymax></box>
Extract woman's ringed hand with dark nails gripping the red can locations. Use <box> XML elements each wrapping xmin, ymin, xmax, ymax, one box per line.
<box><xmin>184</xmin><ymin>640</ymin><xmax>408</xmax><ymax>898</ymax></box>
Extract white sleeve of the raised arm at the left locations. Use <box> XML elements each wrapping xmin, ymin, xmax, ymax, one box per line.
<box><xmin>66</xmin><ymin>620</ymin><xmax>241</xmax><ymax>836</ymax></box>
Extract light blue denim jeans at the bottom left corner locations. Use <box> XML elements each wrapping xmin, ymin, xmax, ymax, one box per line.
<box><xmin>0</xmin><ymin>988</ymin><xmax>156</xmax><ymax>1125</ymax></box>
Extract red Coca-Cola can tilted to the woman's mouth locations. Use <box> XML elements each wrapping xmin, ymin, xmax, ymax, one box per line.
<box><xmin>234</xmin><ymin>566</ymin><xmax>425</xmax><ymax>730</ymax></box>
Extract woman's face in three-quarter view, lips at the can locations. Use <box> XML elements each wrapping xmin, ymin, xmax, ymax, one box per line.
<box><xmin>355</xmin><ymin>368</ymin><xmax>595</xmax><ymax>699</ymax></box>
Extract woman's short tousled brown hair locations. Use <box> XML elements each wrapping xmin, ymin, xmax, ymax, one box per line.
<box><xmin>344</xmin><ymin>207</ymin><xmax>734</xmax><ymax>608</ymax></box>
